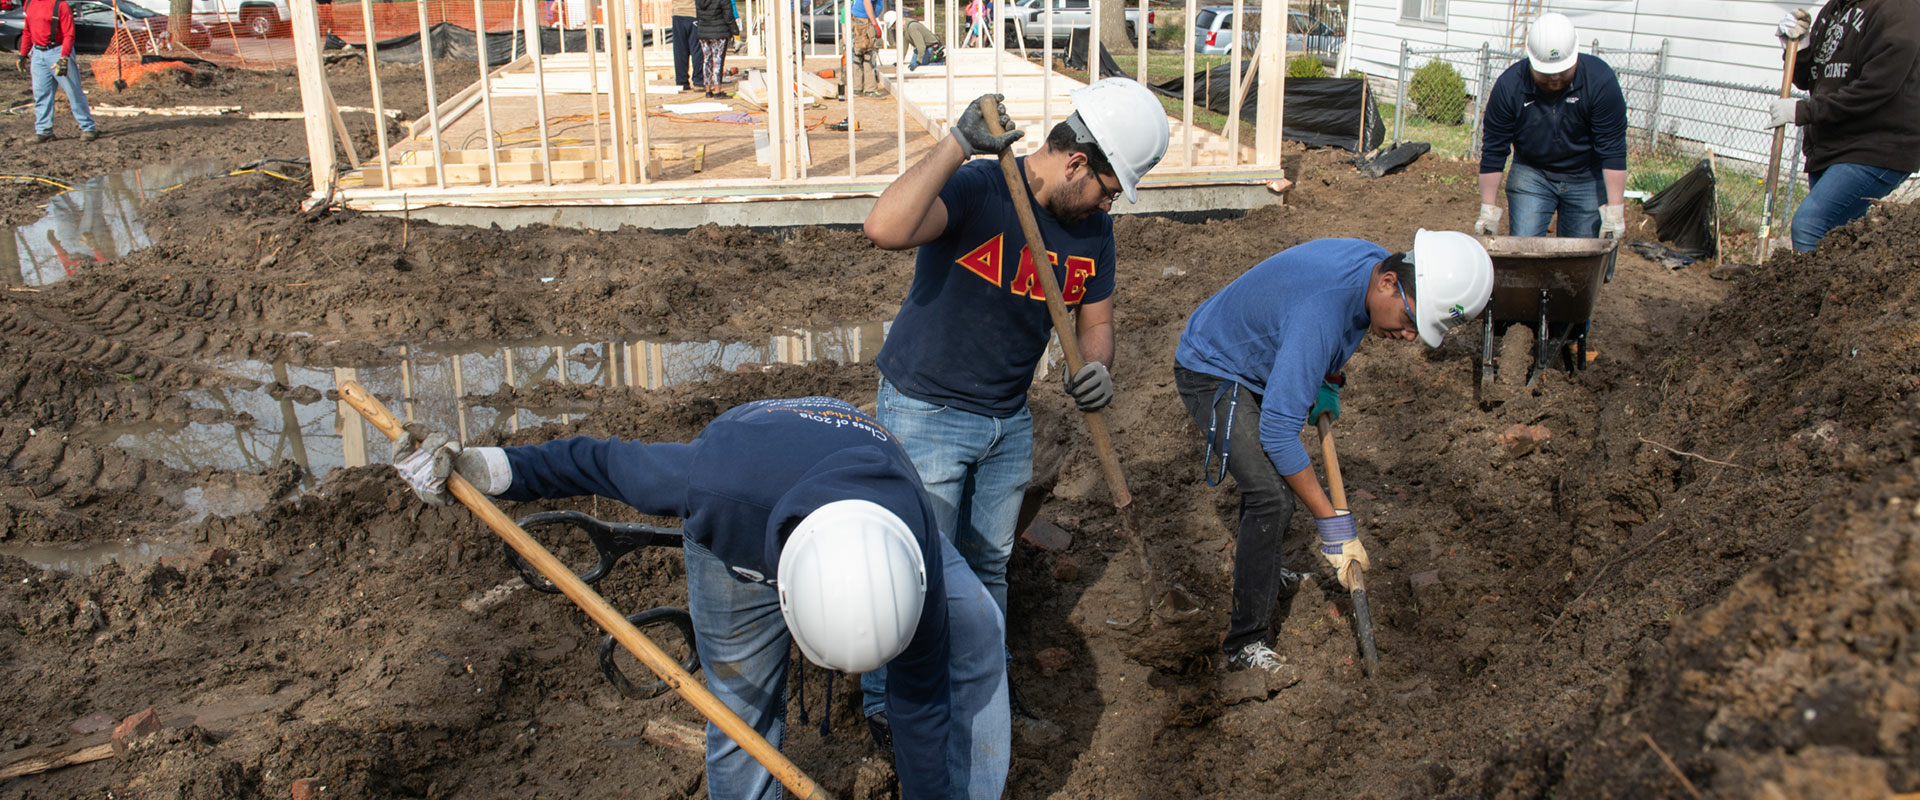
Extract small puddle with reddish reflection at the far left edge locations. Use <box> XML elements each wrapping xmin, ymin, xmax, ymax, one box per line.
<box><xmin>0</xmin><ymin>159</ymin><xmax>227</xmax><ymax>286</ymax></box>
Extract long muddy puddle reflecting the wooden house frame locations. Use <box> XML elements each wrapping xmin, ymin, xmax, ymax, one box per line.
<box><xmin>88</xmin><ymin>322</ymin><xmax>891</xmax><ymax>479</ymax></box>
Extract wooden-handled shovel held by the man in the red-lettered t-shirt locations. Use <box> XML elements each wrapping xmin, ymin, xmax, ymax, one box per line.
<box><xmin>979</xmin><ymin>98</ymin><xmax>1200</xmax><ymax>627</ymax></box>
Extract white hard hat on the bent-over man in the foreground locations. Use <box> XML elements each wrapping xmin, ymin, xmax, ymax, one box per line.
<box><xmin>778</xmin><ymin>501</ymin><xmax>927</xmax><ymax>671</ymax></box>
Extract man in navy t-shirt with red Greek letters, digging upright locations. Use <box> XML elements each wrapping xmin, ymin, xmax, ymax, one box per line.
<box><xmin>862</xmin><ymin>79</ymin><xmax>1167</xmax><ymax>744</ymax></box>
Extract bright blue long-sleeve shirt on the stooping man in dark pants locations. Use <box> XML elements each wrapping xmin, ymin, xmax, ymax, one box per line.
<box><xmin>1173</xmin><ymin>240</ymin><xmax>1392</xmax><ymax>476</ymax></box>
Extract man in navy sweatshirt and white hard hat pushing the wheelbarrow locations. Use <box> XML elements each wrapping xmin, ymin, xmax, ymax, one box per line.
<box><xmin>1473</xmin><ymin>13</ymin><xmax>1626</xmax><ymax>238</ymax></box>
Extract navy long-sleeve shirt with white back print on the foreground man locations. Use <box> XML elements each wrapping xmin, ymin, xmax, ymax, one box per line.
<box><xmin>487</xmin><ymin>397</ymin><xmax>966</xmax><ymax>798</ymax></box>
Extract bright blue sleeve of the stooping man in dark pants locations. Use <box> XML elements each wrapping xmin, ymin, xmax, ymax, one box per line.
<box><xmin>1260</xmin><ymin>312</ymin><xmax>1340</xmax><ymax>476</ymax></box>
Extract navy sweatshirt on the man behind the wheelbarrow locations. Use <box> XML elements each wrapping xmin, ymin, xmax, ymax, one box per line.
<box><xmin>1480</xmin><ymin>54</ymin><xmax>1626</xmax><ymax>180</ymax></box>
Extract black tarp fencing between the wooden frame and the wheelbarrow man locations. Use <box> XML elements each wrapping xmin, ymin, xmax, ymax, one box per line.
<box><xmin>1152</xmin><ymin>61</ymin><xmax>1386</xmax><ymax>153</ymax></box>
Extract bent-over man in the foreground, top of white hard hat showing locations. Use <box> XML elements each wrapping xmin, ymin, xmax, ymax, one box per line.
<box><xmin>396</xmin><ymin>397</ymin><xmax>1010</xmax><ymax>800</ymax></box>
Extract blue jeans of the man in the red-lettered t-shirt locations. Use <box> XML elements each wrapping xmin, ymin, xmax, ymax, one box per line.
<box><xmin>860</xmin><ymin>378</ymin><xmax>1033</xmax><ymax>716</ymax></box>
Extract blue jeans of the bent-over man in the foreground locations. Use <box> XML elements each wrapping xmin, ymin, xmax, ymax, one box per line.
<box><xmin>685</xmin><ymin>539</ymin><xmax>1012</xmax><ymax>800</ymax></box>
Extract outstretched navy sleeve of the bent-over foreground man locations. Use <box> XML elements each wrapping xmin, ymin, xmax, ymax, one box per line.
<box><xmin>499</xmin><ymin>437</ymin><xmax>693</xmax><ymax>518</ymax></box>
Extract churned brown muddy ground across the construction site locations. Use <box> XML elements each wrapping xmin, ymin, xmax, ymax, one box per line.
<box><xmin>0</xmin><ymin>61</ymin><xmax>1920</xmax><ymax>800</ymax></box>
